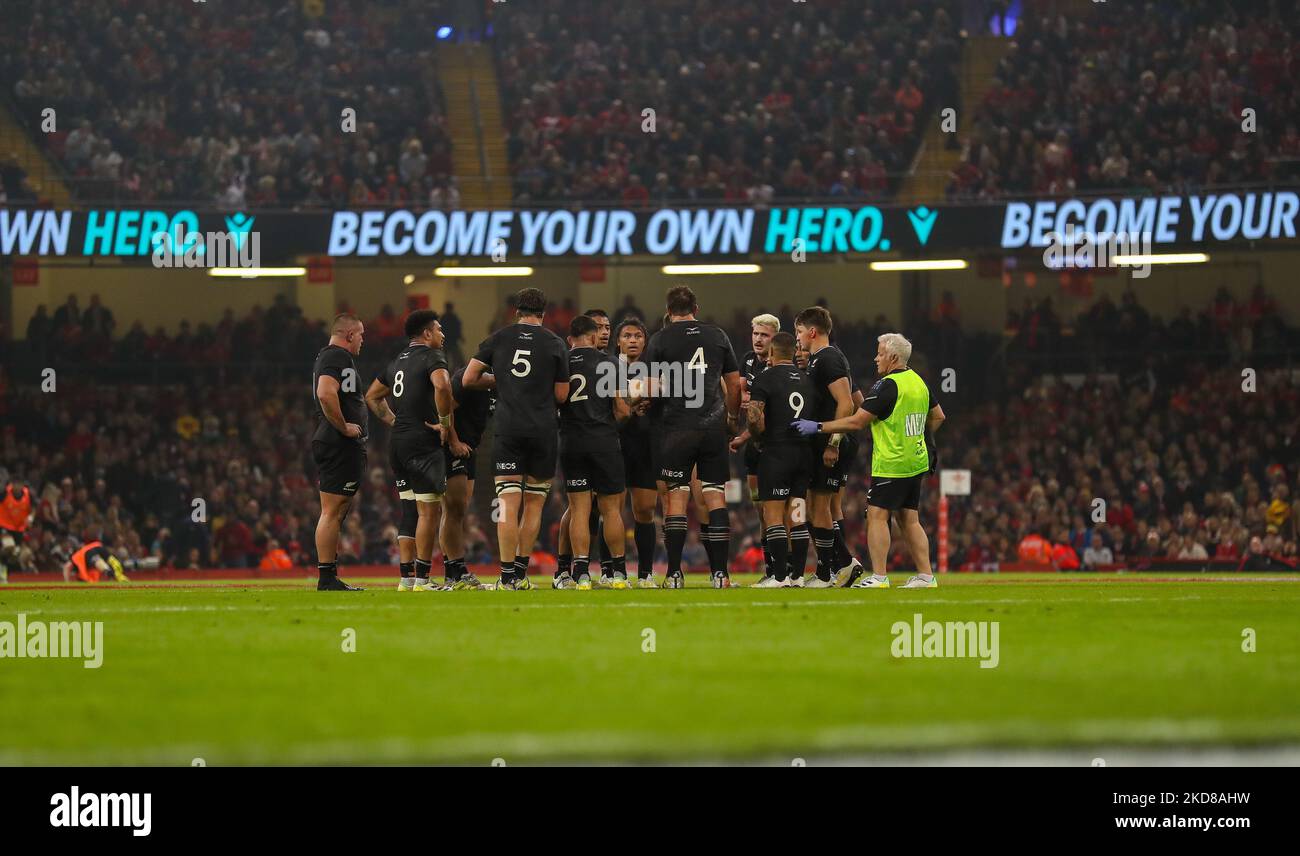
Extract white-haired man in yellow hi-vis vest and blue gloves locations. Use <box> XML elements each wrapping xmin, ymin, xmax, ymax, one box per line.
<box><xmin>793</xmin><ymin>333</ymin><xmax>944</xmax><ymax>588</ymax></box>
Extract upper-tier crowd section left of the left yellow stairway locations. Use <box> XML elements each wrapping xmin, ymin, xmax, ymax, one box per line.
<box><xmin>0</xmin><ymin>0</ymin><xmax>454</xmax><ymax>208</ymax></box>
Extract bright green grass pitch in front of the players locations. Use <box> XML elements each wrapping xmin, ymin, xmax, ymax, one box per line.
<box><xmin>0</xmin><ymin>575</ymin><xmax>1300</xmax><ymax>765</ymax></box>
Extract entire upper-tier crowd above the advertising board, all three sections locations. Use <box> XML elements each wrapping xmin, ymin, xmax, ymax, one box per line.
<box><xmin>0</xmin><ymin>0</ymin><xmax>1300</xmax><ymax>208</ymax></box>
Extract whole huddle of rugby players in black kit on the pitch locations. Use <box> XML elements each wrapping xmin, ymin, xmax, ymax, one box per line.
<box><xmin>312</xmin><ymin>286</ymin><xmax>862</xmax><ymax>591</ymax></box>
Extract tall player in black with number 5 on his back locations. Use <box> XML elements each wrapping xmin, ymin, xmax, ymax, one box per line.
<box><xmin>464</xmin><ymin>289</ymin><xmax>569</xmax><ymax>591</ymax></box>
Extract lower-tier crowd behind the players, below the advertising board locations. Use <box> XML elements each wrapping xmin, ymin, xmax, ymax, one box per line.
<box><xmin>0</xmin><ymin>283</ymin><xmax>1300</xmax><ymax>570</ymax></box>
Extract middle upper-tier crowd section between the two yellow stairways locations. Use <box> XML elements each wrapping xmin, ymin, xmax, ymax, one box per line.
<box><xmin>495</xmin><ymin>0</ymin><xmax>961</xmax><ymax>206</ymax></box>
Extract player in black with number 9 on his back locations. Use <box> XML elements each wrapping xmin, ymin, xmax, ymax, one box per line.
<box><xmin>749</xmin><ymin>333</ymin><xmax>816</xmax><ymax>588</ymax></box>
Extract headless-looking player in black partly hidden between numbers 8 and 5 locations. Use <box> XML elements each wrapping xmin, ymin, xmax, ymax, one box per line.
<box><xmin>442</xmin><ymin>359</ymin><xmax>497</xmax><ymax>591</ymax></box>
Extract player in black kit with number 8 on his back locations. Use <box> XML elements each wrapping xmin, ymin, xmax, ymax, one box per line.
<box><xmin>365</xmin><ymin>310</ymin><xmax>451</xmax><ymax>592</ymax></box>
